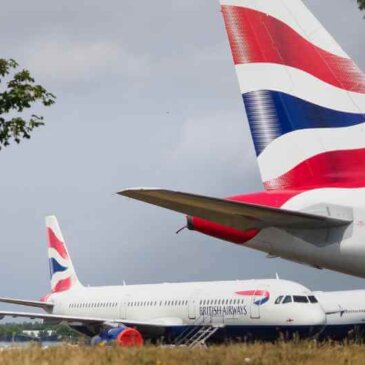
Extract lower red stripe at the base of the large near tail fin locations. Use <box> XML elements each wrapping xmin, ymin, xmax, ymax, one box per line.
<box><xmin>264</xmin><ymin>148</ymin><xmax>365</xmax><ymax>190</ymax></box>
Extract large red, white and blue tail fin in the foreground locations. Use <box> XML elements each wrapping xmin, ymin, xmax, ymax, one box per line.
<box><xmin>221</xmin><ymin>0</ymin><xmax>365</xmax><ymax>190</ymax></box>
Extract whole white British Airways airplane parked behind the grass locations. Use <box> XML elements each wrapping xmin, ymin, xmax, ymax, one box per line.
<box><xmin>0</xmin><ymin>216</ymin><xmax>326</xmax><ymax>346</ymax></box>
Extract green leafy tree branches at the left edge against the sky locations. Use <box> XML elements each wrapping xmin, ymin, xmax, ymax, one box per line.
<box><xmin>0</xmin><ymin>58</ymin><xmax>56</xmax><ymax>150</ymax></box>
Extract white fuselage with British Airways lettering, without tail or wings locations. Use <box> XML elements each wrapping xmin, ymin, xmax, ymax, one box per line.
<box><xmin>48</xmin><ymin>280</ymin><xmax>325</xmax><ymax>338</ymax></box>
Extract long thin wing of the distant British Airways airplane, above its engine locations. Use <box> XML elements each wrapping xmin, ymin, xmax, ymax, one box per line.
<box><xmin>0</xmin><ymin>311</ymin><xmax>183</xmax><ymax>328</ymax></box>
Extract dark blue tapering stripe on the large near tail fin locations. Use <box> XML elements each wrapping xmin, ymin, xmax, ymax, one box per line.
<box><xmin>243</xmin><ymin>90</ymin><xmax>365</xmax><ymax>155</ymax></box>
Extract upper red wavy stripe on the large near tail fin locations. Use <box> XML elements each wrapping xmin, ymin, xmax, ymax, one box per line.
<box><xmin>222</xmin><ymin>5</ymin><xmax>365</xmax><ymax>93</ymax></box>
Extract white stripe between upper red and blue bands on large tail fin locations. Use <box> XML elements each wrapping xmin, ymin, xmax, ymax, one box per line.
<box><xmin>236</xmin><ymin>63</ymin><xmax>365</xmax><ymax>114</ymax></box>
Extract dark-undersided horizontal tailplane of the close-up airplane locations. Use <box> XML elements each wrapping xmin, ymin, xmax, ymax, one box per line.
<box><xmin>118</xmin><ymin>188</ymin><xmax>352</xmax><ymax>230</ymax></box>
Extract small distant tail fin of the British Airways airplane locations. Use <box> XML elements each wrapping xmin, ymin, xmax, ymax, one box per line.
<box><xmin>46</xmin><ymin>216</ymin><xmax>81</xmax><ymax>293</ymax></box>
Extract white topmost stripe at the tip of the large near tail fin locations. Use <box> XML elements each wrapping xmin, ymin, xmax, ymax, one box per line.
<box><xmin>221</xmin><ymin>0</ymin><xmax>349</xmax><ymax>58</ymax></box>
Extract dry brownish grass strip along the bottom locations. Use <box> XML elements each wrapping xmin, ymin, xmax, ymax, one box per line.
<box><xmin>0</xmin><ymin>342</ymin><xmax>365</xmax><ymax>365</ymax></box>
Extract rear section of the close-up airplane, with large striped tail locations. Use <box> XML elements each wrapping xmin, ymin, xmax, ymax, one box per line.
<box><xmin>119</xmin><ymin>0</ymin><xmax>365</xmax><ymax>278</ymax></box>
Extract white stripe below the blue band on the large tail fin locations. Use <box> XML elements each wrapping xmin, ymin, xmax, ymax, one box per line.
<box><xmin>258</xmin><ymin>124</ymin><xmax>365</xmax><ymax>181</ymax></box>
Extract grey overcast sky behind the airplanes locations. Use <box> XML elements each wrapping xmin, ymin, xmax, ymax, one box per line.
<box><xmin>0</xmin><ymin>0</ymin><xmax>365</xmax><ymax>298</ymax></box>
